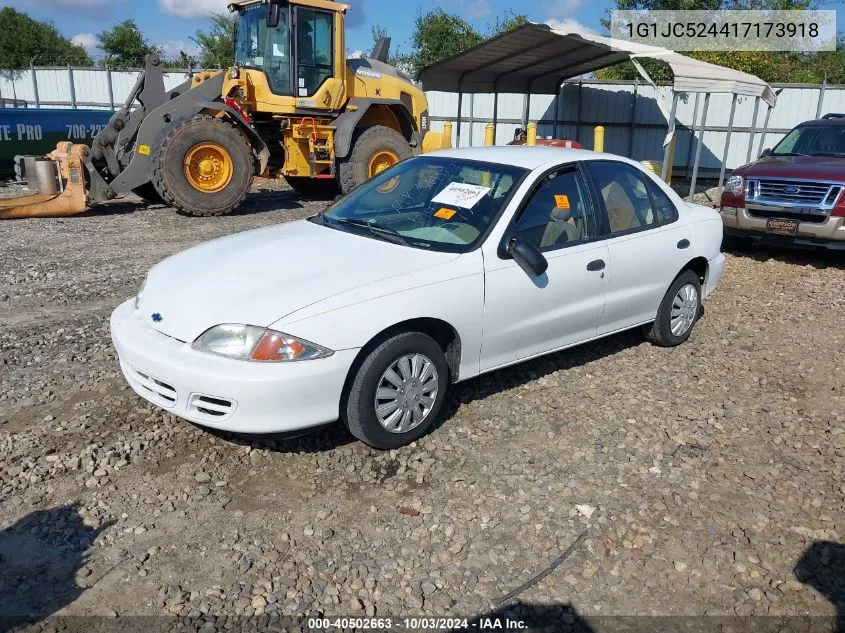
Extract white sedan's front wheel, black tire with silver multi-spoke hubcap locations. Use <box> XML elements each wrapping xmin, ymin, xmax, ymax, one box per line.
<box><xmin>343</xmin><ymin>332</ymin><xmax>449</xmax><ymax>450</ymax></box>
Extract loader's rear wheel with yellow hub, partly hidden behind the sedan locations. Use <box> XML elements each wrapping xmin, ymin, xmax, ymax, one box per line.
<box><xmin>339</xmin><ymin>125</ymin><xmax>414</xmax><ymax>193</ymax></box>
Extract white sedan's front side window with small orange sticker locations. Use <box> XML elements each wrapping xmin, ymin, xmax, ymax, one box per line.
<box><xmin>516</xmin><ymin>167</ymin><xmax>595</xmax><ymax>251</ymax></box>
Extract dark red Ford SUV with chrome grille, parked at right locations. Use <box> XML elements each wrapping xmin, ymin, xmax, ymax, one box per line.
<box><xmin>720</xmin><ymin>114</ymin><xmax>845</xmax><ymax>250</ymax></box>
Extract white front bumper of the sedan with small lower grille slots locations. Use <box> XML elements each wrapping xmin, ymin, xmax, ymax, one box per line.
<box><xmin>111</xmin><ymin>300</ymin><xmax>358</xmax><ymax>433</ymax></box>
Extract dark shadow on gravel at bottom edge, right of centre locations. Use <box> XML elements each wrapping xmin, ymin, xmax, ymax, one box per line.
<box><xmin>454</xmin><ymin>602</ymin><xmax>595</xmax><ymax>633</ymax></box>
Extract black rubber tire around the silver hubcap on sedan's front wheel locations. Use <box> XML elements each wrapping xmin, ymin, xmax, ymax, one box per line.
<box><xmin>343</xmin><ymin>332</ymin><xmax>449</xmax><ymax>450</ymax></box>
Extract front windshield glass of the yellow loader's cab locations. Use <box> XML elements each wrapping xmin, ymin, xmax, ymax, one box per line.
<box><xmin>235</xmin><ymin>4</ymin><xmax>291</xmax><ymax>95</ymax></box>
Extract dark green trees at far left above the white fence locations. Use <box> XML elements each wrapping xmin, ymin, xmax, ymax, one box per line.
<box><xmin>0</xmin><ymin>7</ymin><xmax>93</xmax><ymax>75</ymax></box>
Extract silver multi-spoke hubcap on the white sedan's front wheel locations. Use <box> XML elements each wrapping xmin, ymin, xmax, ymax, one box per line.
<box><xmin>375</xmin><ymin>354</ymin><xmax>438</xmax><ymax>433</ymax></box>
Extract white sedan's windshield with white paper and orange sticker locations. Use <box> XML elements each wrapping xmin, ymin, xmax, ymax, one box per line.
<box><xmin>315</xmin><ymin>156</ymin><xmax>527</xmax><ymax>252</ymax></box>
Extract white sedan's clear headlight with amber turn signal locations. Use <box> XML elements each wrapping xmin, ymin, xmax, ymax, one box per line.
<box><xmin>192</xmin><ymin>323</ymin><xmax>334</xmax><ymax>363</ymax></box>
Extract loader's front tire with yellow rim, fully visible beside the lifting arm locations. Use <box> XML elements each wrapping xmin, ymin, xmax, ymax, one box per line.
<box><xmin>152</xmin><ymin>115</ymin><xmax>255</xmax><ymax>216</ymax></box>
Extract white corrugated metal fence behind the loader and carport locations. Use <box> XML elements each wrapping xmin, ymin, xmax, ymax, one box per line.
<box><xmin>0</xmin><ymin>68</ymin><xmax>845</xmax><ymax>172</ymax></box>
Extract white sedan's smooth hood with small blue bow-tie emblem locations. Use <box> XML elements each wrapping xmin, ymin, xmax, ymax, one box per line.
<box><xmin>139</xmin><ymin>220</ymin><xmax>458</xmax><ymax>342</ymax></box>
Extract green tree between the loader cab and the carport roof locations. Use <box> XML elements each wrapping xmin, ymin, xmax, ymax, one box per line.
<box><xmin>408</xmin><ymin>9</ymin><xmax>484</xmax><ymax>71</ymax></box>
